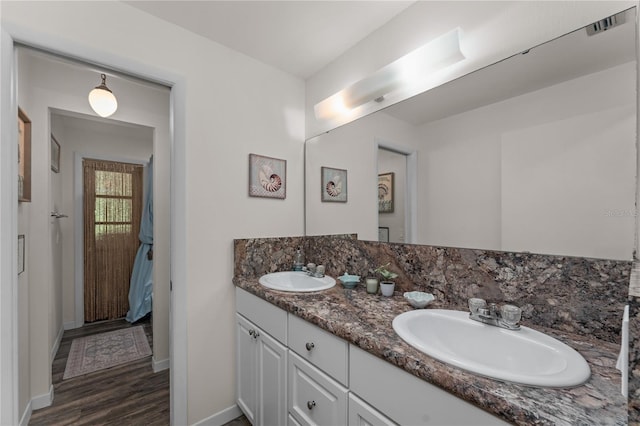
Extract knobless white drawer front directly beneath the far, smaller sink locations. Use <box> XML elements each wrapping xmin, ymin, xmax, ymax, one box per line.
<box><xmin>236</xmin><ymin>287</ymin><xmax>287</xmax><ymax>345</ymax></box>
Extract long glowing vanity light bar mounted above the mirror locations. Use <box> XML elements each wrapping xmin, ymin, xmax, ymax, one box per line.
<box><xmin>314</xmin><ymin>28</ymin><xmax>465</xmax><ymax>120</ymax></box>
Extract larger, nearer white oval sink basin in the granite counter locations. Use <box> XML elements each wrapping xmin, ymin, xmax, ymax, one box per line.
<box><xmin>393</xmin><ymin>309</ymin><xmax>591</xmax><ymax>387</ymax></box>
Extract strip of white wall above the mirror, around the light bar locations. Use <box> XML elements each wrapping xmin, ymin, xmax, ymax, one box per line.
<box><xmin>305</xmin><ymin>1</ymin><xmax>637</xmax><ymax>138</ymax></box>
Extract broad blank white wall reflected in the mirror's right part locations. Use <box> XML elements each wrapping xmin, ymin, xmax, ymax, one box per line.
<box><xmin>418</xmin><ymin>62</ymin><xmax>636</xmax><ymax>260</ymax></box>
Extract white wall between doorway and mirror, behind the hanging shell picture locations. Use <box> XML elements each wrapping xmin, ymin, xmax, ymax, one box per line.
<box><xmin>1</xmin><ymin>1</ymin><xmax>304</xmax><ymax>424</ymax></box>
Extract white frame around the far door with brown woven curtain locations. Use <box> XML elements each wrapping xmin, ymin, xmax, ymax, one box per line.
<box><xmin>74</xmin><ymin>152</ymin><xmax>149</xmax><ymax>329</ymax></box>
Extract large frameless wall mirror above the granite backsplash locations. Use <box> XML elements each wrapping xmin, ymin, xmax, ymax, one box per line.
<box><xmin>305</xmin><ymin>8</ymin><xmax>638</xmax><ymax>260</ymax></box>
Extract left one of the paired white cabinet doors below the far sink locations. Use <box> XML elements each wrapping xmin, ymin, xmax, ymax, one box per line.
<box><xmin>236</xmin><ymin>314</ymin><xmax>258</xmax><ymax>424</ymax></box>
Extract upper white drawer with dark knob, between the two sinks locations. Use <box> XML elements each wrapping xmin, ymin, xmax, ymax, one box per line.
<box><xmin>289</xmin><ymin>315</ymin><xmax>349</xmax><ymax>386</ymax></box>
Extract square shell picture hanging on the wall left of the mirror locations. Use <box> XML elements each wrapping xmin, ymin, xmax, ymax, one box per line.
<box><xmin>249</xmin><ymin>154</ymin><xmax>287</xmax><ymax>200</ymax></box>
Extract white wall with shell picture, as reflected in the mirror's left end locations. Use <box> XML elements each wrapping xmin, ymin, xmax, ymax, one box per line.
<box><xmin>305</xmin><ymin>114</ymin><xmax>417</xmax><ymax>241</ymax></box>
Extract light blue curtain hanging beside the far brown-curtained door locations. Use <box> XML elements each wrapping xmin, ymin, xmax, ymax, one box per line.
<box><xmin>126</xmin><ymin>156</ymin><xmax>153</xmax><ymax>322</ymax></box>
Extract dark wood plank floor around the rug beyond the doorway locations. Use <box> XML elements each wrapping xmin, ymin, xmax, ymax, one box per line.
<box><xmin>29</xmin><ymin>318</ymin><xmax>169</xmax><ymax>426</ymax></box>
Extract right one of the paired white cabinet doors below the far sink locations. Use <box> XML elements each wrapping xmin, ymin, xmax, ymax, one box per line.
<box><xmin>254</xmin><ymin>330</ymin><xmax>287</xmax><ymax>426</ymax></box>
